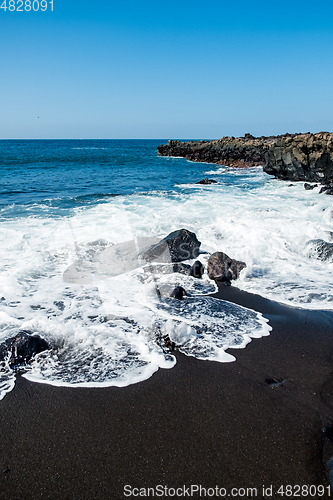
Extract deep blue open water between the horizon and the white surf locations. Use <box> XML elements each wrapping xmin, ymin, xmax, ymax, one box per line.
<box><xmin>0</xmin><ymin>140</ymin><xmax>210</xmax><ymax>208</ymax></box>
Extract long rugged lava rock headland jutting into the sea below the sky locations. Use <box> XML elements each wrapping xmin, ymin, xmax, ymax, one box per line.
<box><xmin>158</xmin><ymin>132</ymin><xmax>333</xmax><ymax>188</ymax></box>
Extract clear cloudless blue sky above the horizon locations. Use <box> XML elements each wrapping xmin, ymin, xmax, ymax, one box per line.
<box><xmin>0</xmin><ymin>0</ymin><xmax>333</xmax><ymax>139</ymax></box>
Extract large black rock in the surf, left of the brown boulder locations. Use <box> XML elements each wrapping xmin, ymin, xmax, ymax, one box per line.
<box><xmin>140</xmin><ymin>229</ymin><xmax>201</xmax><ymax>262</ymax></box>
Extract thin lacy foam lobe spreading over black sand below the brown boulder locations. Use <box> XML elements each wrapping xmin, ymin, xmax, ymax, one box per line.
<box><xmin>141</xmin><ymin>290</ymin><xmax>271</xmax><ymax>362</ymax></box>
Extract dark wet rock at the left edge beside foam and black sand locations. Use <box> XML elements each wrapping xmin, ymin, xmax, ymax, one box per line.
<box><xmin>0</xmin><ymin>330</ymin><xmax>50</xmax><ymax>368</ymax></box>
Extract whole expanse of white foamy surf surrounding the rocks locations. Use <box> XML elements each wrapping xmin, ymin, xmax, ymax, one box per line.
<box><xmin>0</xmin><ymin>165</ymin><xmax>333</xmax><ymax>393</ymax></box>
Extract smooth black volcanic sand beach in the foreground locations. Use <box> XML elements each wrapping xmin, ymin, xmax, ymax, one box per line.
<box><xmin>0</xmin><ymin>286</ymin><xmax>333</xmax><ymax>500</ymax></box>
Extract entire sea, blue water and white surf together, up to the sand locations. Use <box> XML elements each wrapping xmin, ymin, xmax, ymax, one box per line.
<box><xmin>0</xmin><ymin>140</ymin><xmax>333</xmax><ymax>398</ymax></box>
